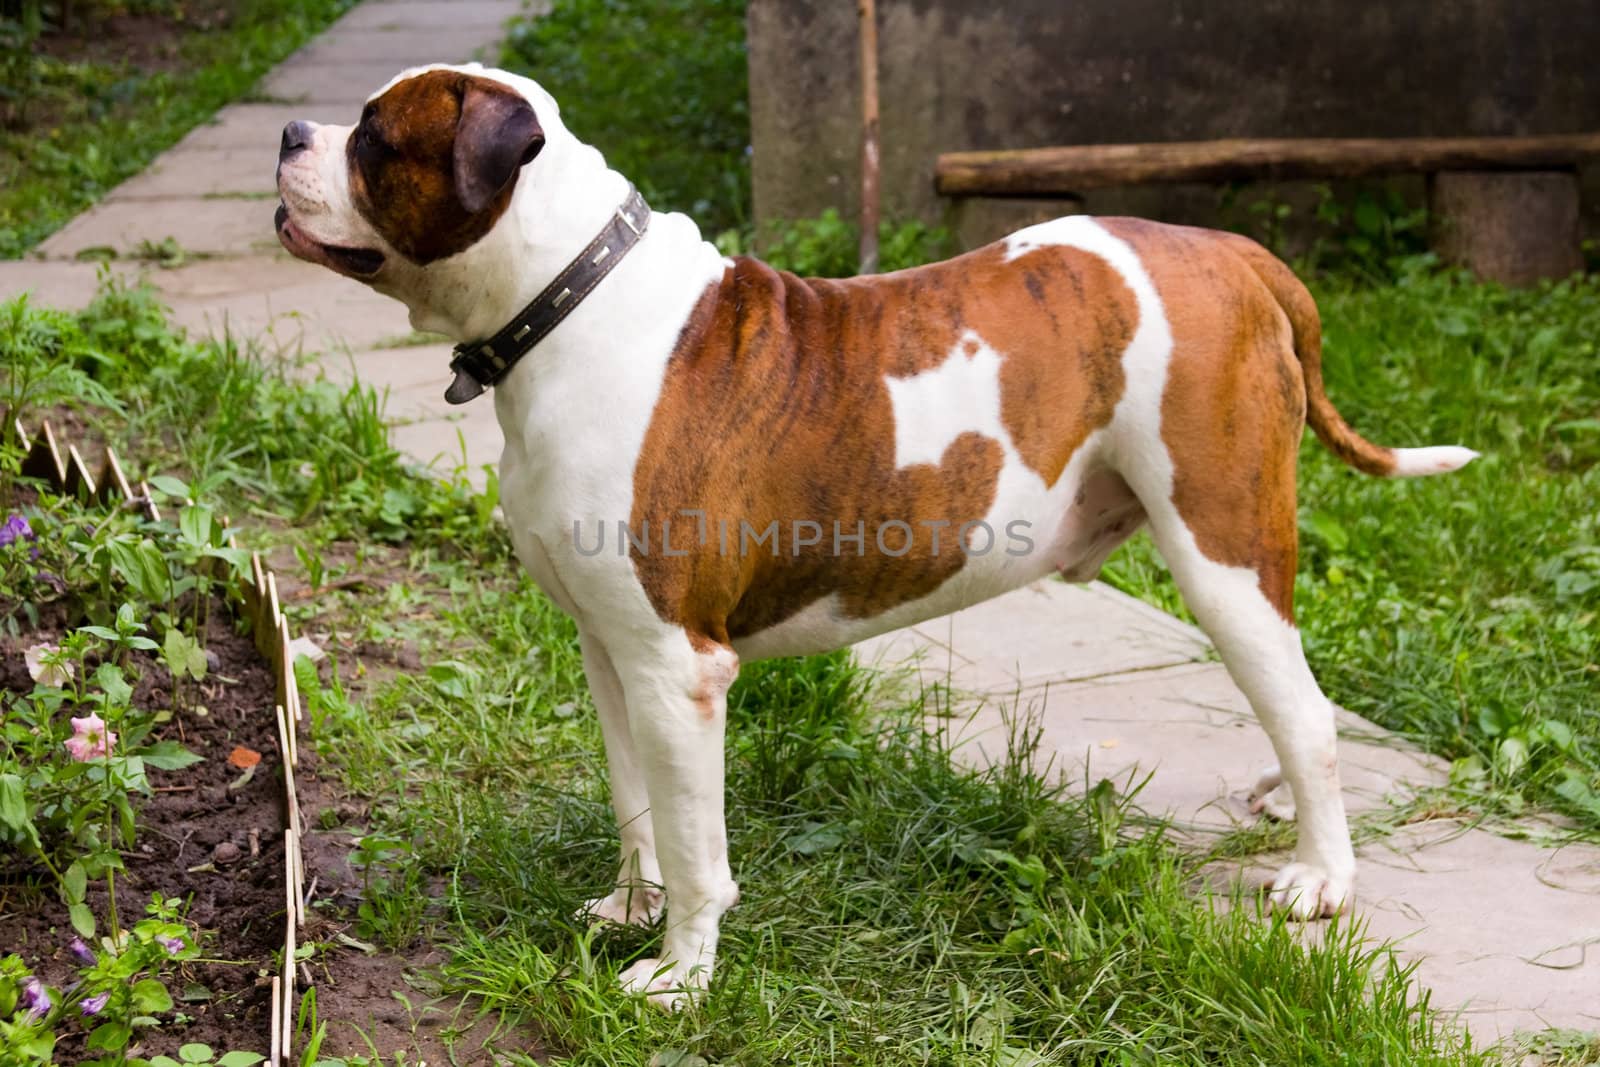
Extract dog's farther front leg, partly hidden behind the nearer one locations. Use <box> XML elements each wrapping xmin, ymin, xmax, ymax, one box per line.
<box><xmin>579</xmin><ymin>632</ymin><xmax>662</xmax><ymax>926</ymax></box>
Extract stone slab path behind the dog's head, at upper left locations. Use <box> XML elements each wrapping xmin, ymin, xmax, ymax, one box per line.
<box><xmin>0</xmin><ymin>0</ymin><xmax>523</xmax><ymax>483</ymax></box>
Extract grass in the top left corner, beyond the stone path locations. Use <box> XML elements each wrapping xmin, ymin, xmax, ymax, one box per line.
<box><xmin>0</xmin><ymin>0</ymin><xmax>355</xmax><ymax>259</ymax></box>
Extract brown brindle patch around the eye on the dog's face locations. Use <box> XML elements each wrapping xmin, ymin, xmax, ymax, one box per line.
<box><xmin>346</xmin><ymin>70</ymin><xmax>526</xmax><ymax>264</ymax></box>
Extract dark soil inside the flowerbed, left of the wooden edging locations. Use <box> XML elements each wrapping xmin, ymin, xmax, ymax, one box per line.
<box><xmin>0</xmin><ymin>605</ymin><xmax>285</xmax><ymax>1062</ymax></box>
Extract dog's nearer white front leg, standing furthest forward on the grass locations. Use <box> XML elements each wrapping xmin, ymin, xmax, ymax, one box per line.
<box><xmin>611</xmin><ymin>632</ymin><xmax>739</xmax><ymax>1009</ymax></box>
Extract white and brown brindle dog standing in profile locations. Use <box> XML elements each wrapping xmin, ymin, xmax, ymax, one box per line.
<box><xmin>278</xmin><ymin>66</ymin><xmax>1474</xmax><ymax>1006</ymax></box>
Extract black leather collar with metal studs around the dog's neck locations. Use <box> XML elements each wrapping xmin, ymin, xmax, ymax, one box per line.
<box><xmin>445</xmin><ymin>182</ymin><xmax>650</xmax><ymax>403</ymax></box>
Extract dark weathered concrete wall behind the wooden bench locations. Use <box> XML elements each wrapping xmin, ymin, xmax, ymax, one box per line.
<box><xmin>749</xmin><ymin>0</ymin><xmax>1600</xmax><ymax>243</ymax></box>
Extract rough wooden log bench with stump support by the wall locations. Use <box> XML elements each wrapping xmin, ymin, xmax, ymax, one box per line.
<box><xmin>934</xmin><ymin>133</ymin><xmax>1600</xmax><ymax>285</ymax></box>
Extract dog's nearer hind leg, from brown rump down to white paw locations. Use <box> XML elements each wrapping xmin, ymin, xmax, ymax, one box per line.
<box><xmin>1104</xmin><ymin>221</ymin><xmax>1355</xmax><ymax>918</ymax></box>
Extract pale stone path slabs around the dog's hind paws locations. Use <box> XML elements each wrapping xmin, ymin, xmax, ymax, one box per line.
<box><xmin>858</xmin><ymin>581</ymin><xmax>1600</xmax><ymax>1043</ymax></box>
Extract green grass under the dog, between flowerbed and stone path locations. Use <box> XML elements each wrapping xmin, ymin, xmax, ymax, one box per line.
<box><xmin>0</xmin><ymin>279</ymin><xmax>1488</xmax><ymax>1065</ymax></box>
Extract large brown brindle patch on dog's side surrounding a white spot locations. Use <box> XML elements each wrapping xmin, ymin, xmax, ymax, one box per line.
<box><xmin>630</xmin><ymin>245</ymin><xmax>1138</xmax><ymax>645</ymax></box>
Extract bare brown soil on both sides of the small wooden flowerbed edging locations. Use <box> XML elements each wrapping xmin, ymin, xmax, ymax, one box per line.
<box><xmin>0</xmin><ymin>508</ymin><xmax>546</xmax><ymax>1067</ymax></box>
